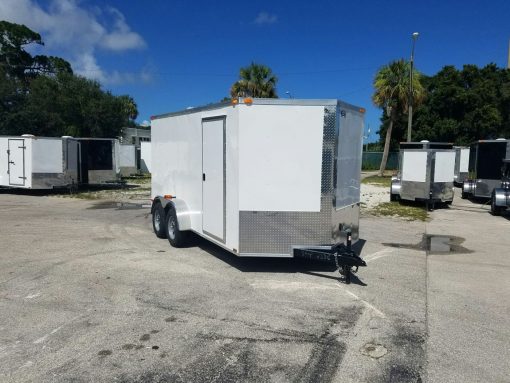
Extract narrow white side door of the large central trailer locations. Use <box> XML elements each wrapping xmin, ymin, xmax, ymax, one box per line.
<box><xmin>202</xmin><ymin>116</ymin><xmax>226</xmax><ymax>242</ymax></box>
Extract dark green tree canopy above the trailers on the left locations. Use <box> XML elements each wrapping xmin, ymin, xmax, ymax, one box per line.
<box><xmin>0</xmin><ymin>21</ymin><xmax>138</xmax><ymax>138</ymax></box>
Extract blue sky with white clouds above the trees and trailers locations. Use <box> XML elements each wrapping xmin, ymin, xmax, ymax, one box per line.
<box><xmin>0</xmin><ymin>0</ymin><xmax>510</xmax><ymax>142</ymax></box>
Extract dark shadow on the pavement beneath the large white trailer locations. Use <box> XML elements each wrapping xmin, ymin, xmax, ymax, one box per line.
<box><xmin>189</xmin><ymin>234</ymin><xmax>367</xmax><ymax>286</ymax></box>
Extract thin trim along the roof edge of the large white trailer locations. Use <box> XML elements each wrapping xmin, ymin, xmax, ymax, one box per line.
<box><xmin>151</xmin><ymin>98</ymin><xmax>364</xmax><ymax>120</ymax></box>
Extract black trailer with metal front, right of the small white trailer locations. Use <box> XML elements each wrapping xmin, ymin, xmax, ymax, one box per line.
<box><xmin>462</xmin><ymin>138</ymin><xmax>510</xmax><ymax>198</ymax></box>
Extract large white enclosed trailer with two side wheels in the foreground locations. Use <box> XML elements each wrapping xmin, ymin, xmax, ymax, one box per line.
<box><xmin>151</xmin><ymin>98</ymin><xmax>365</xmax><ymax>281</ymax></box>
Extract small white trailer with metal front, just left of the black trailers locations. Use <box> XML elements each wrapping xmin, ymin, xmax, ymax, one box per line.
<box><xmin>390</xmin><ymin>141</ymin><xmax>455</xmax><ymax>208</ymax></box>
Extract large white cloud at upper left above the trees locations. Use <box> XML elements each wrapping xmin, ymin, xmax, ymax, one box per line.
<box><xmin>0</xmin><ymin>0</ymin><xmax>148</xmax><ymax>84</ymax></box>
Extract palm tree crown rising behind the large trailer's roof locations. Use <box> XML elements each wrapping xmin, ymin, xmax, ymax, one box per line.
<box><xmin>230</xmin><ymin>62</ymin><xmax>278</xmax><ymax>98</ymax></box>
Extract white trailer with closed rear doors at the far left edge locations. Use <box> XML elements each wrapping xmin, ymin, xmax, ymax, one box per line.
<box><xmin>0</xmin><ymin>135</ymin><xmax>79</xmax><ymax>189</ymax></box>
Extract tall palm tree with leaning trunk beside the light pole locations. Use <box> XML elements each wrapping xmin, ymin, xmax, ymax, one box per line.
<box><xmin>372</xmin><ymin>59</ymin><xmax>425</xmax><ymax>176</ymax></box>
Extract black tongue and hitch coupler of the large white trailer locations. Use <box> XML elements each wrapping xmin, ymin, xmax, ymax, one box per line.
<box><xmin>294</xmin><ymin>233</ymin><xmax>367</xmax><ymax>284</ymax></box>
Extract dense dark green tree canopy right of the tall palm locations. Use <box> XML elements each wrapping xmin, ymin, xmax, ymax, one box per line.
<box><xmin>379</xmin><ymin>64</ymin><xmax>510</xmax><ymax>149</ymax></box>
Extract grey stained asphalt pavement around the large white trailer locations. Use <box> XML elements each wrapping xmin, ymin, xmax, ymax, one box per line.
<box><xmin>0</xmin><ymin>193</ymin><xmax>510</xmax><ymax>383</ymax></box>
